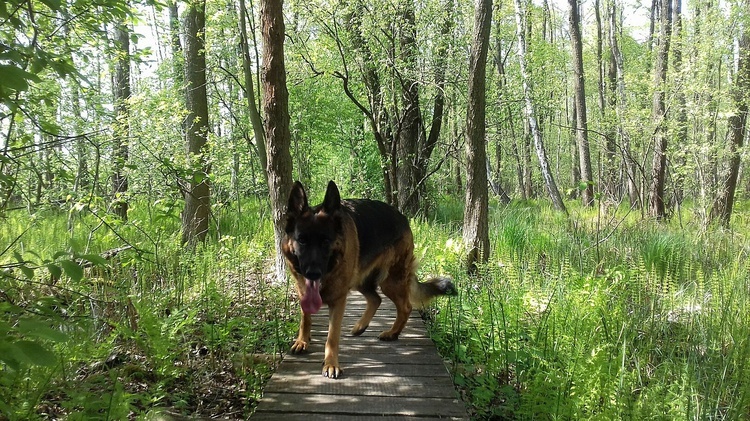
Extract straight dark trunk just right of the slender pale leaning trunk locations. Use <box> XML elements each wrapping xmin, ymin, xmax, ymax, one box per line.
<box><xmin>568</xmin><ymin>0</ymin><xmax>594</xmax><ymax>206</ymax></box>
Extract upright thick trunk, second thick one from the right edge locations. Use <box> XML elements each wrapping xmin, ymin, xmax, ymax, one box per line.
<box><xmin>649</xmin><ymin>0</ymin><xmax>672</xmax><ymax>219</ymax></box>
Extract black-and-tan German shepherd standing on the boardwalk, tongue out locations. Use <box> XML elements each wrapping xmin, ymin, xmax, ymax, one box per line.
<box><xmin>282</xmin><ymin>181</ymin><xmax>455</xmax><ymax>378</ymax></box>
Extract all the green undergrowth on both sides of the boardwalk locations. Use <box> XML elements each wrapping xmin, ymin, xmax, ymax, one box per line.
<box><xmin>0</xmin><ymin>198</ymin><xmax>750</xmax><ymax>420</ymax></box>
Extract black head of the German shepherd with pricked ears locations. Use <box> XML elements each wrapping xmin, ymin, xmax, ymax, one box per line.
<box><xmin>284</xmin><ymin>181</ymin><xmax>341</xmax><ymax>283</ymax></box>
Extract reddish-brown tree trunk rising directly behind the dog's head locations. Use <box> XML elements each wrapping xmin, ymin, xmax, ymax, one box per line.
<box><xmin>260</xmin><ymin>0</ymin><xmax>292</xmax><ymax>282</ymax></box>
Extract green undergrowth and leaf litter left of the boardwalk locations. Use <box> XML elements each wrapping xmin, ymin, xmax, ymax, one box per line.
<box><xmin>0</xmin><ymin>201</ymin><xmax>296</xmax><ymax>420</ymax></box>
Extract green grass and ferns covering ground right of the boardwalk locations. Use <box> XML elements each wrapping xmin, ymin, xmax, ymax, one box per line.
<box><xmin>417</xmin><ymin>199</ymin><xmax>750</xmax><ymax>420</ymax></box>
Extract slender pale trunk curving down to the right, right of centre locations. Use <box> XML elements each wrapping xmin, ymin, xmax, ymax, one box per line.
<box><xmin>513</xmin><ymin>0</ymin><xmax>568</xmax><ymax>215</ymax></box>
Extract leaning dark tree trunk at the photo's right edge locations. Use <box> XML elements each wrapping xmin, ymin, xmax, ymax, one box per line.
<box><xmin>711</xmin><ymin>21</ymin><xmax>750</xmax><ymax>227</ymax></box>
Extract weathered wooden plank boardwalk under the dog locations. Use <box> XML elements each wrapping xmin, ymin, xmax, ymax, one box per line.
<box><xmin>252</xmin><ymin>293</ymin><xmax>468</xmax><ymax>420</ymax></box>
